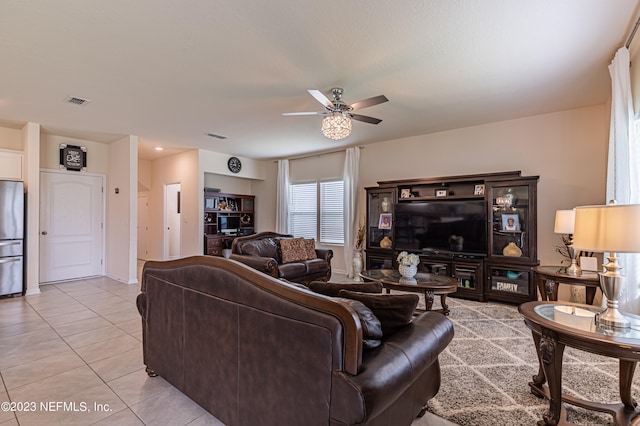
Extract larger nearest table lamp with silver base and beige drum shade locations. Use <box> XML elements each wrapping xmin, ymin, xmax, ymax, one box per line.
<box><xmin>573</xmin><ymin>204</ymin><xmax>640</xmax><ymax>328</ymax></box>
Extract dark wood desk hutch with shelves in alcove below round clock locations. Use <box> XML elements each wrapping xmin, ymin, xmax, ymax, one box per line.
<box><xmin>203</xmin><ymin>188</ymin><xmax>255</xmax><ymax>256</ymax></box>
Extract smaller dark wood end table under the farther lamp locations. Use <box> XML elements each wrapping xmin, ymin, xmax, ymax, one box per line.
<box><xmin>532</xmin><ymin>266</ymin><xmax>600</xmax><ymax>305</ymax></box>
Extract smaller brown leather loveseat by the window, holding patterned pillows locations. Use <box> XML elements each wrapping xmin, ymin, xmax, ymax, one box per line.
<box><xmin>231</xmin><ymin>232</ymin><xmax>333</xmax><ymax>283</ymax></box>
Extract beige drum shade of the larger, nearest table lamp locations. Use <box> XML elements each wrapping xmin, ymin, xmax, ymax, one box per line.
<box><xmin>573</xmin><ymin>204</ymin><xmax>640</xmax><ymax>253</ymax></box>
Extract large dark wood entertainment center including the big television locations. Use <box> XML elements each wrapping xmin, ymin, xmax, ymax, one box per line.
<box><xmin>365</xmin><ymin>171</ymin><xmax>539</xmax><ymax>303</ymax></box>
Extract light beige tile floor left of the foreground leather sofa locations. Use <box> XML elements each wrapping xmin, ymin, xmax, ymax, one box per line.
<box><xmin>0</xmin><ymin>270</ymin><xmax>451</xmax><ymax>426</ymax></box>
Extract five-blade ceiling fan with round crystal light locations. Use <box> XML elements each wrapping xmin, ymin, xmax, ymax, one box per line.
<box><xmin>282</xmin><ymin>87</ymin><xmax>389</xmax><ymax>140</ymax></box>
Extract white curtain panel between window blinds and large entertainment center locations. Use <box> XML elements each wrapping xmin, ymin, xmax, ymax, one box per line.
<box><xmin>342</xmin><ymin>147</ymin><xmax>360</xmax><ymax>278</ymax></box>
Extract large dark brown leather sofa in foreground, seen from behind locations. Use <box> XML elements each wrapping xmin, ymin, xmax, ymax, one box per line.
<box><xmin>137</xmin><ymin>256</ymin><xmax>453</xmax><ymax>426</ymax></box>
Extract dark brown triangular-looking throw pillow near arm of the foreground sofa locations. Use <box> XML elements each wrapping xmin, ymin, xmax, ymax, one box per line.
<box><xmin>338</xmin><ymin>290</ymin><xmax>419</xmax><ymax>337</ymax></box>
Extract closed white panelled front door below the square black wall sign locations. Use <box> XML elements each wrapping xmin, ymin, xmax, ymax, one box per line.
<box><xmin>40</xmin><ymin>172</ymin><xmax>104</xmax><ymax>282</ymax></box>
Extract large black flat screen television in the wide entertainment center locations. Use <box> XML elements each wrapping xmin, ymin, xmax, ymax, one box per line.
<box><xmin>395</xmin><ymin>200</ymin><xmax>487</xmax><ymax>255</ymax></box>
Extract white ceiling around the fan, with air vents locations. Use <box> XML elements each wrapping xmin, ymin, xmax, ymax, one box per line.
<box><xmin>0</xmin><ymin>0</ymin><xmax>639</xmax><ymax>159</ymax></box>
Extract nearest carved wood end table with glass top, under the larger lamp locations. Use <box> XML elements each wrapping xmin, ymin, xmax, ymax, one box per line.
<box><xmin>518</xmin><ymin>302</ymin><xmax>640</xmax><ymax>426</ymax></box>
